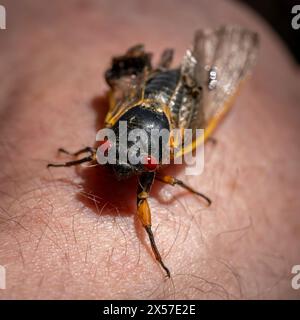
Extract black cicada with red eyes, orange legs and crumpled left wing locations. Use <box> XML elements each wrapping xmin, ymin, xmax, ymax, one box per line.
<box><xmin>48</xmin><ymin>26</ymin><xmax>258</xmax><ymax>277</ymax></box>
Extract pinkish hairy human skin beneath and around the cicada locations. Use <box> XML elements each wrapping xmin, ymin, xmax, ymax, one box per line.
<box><xmin>0</xmin><ymin>0</ymin><xmax>300</xmax><ymax>299</ymax></box>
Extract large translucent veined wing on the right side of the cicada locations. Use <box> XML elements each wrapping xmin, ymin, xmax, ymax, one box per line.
<box><xmin>179</xmin><ymin>26</ymin><xmax>258</xmax><ymax>134</ymax></box>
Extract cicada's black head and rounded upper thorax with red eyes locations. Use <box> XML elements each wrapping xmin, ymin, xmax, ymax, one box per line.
<box><xmin>105</xmin><ymin>105</ymin><xmax>169</xmax><ymax>179</ymax></box>
